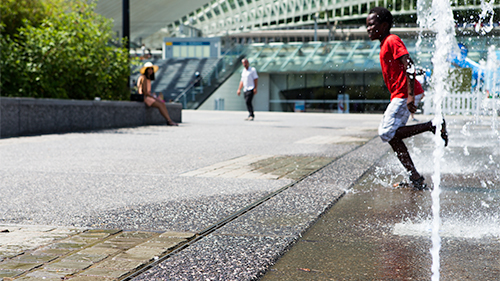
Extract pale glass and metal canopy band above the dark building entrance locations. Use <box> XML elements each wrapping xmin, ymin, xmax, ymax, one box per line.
<box><xmin>247</xmin><ymin>37</ymin><xmax>500</xmax><ymax>73</ymax></box>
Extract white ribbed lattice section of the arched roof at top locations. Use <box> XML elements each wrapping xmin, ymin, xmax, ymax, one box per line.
<box><xmin>169</xmin><ymin>0</ymin><xmax>500</xmax><ymax>36</ymax></box>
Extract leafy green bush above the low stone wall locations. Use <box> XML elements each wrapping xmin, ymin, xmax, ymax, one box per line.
<box><xmin>0</xmin><ymin>0</ymin><xmax>130</xmax><ymax>100</ymax></box>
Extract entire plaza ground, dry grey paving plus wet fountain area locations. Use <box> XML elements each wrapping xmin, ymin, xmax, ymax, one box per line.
<box><xmin>0</xmin><ymin>111</ymin><xmax>500</xmax><ymax>281</ymax></box>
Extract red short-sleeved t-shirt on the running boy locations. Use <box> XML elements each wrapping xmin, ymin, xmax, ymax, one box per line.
<box><xmin>380</xmin><ymin>34</ymin><xmax>412</xmax><ymax>100</ymax></box>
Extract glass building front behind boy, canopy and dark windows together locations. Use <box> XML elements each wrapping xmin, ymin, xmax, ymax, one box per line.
<box><xmin>247</xmin><ymin>36</ymin><xmax>500</xmax><ymax>112</ymax></box>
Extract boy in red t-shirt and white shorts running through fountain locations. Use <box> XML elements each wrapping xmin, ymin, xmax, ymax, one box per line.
<box><xmin>366</xmin><ymin>7</ymin><xmax>448</xmax><ymax>190</ymax></box>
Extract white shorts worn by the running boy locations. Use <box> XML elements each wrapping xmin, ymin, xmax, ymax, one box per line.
<box><xmin>378</xmin><ymin>98</ymin><xmax>410</xmax><ymax>142</ymax></box>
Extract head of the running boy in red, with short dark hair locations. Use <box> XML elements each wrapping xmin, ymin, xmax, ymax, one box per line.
<box><xmin>366</xmin><ymin>7</ymin><xmax>393</xmax><ymax>40</ymax></box>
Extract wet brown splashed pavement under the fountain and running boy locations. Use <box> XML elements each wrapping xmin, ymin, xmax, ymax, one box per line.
<box><xmin>262</xmin><ymin>114</ymin><xmax>500</xmax><ymax>281</ymax></box>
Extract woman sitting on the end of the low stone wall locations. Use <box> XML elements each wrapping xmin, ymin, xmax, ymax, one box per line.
<box><xmin>137</xmin><ymin>62</ymin><xmax>178</xmax><ymax>126</ymax></box>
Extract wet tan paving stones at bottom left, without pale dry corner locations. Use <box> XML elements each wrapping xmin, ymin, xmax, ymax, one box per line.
<box><xmin>0</xmin><ymin>229</ymin><xmax>195</xmax><ymax>281</ymax></box>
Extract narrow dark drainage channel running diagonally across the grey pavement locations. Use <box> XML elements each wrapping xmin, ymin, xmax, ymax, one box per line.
<box><xmin>119</xmin><ymin>156</ymin><xmax>342</xmax><ymax>281</ymax></box>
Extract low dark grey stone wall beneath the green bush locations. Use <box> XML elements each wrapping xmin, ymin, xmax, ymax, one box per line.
<box><xmin>0</xmin><ymin>97</ymin><xmax>182</xmax><ymax>138</ymax></box>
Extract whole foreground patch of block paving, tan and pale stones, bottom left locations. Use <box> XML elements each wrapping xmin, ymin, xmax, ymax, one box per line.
<box><xmin>0</xmin><ymin>225</ymin><xmax>195</xmax><ymax>280</ymax></box>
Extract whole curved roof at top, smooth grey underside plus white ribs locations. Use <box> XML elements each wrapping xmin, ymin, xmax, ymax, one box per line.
<box><xmin>96</xmin><ymin>0</ymin><xmax>500</xmax><ymax>48</ymax></box>
